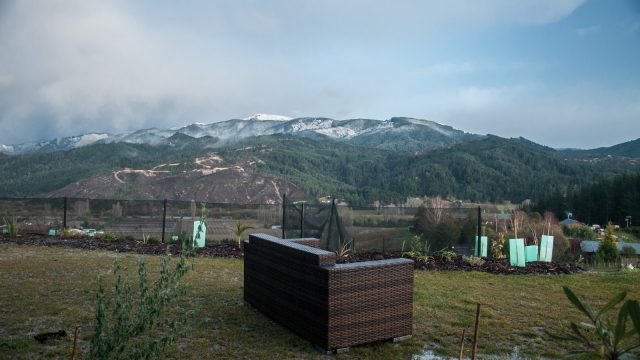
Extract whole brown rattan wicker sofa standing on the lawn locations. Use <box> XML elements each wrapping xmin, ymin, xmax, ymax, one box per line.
<box><xmin>244</xmin><ymin>234</ymin><xmax>413</xmax><ymax>351</ymax></box>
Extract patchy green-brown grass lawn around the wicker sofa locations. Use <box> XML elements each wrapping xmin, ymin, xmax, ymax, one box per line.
<box><xmin>0</xmin><ymin>244</ymin><xmax>640</xmax><ymax>359</ymax></box>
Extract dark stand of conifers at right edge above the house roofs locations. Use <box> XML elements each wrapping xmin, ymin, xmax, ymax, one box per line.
<box><xmin>536</xmin><ymin>172</ymin><xmax>640</xmax><ymax>226</ymax></box>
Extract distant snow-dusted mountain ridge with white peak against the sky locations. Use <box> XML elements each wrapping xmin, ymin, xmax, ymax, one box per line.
<box><xmin>0</xmin><ymin>114</ymin><xmax>478</xmax><ymax>154</ymax></box>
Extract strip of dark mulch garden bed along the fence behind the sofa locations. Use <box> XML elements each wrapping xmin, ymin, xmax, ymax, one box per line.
<box><xmin>0</xmin><ymin>236</ymin><xmax>584</xmax><ymax>275</ymax></box>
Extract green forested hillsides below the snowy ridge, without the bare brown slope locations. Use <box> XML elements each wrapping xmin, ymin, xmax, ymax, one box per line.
<box><xmin>0</xmin><ymin>134</ymin><xmax>630</xmax><ymax>205</ymax></box>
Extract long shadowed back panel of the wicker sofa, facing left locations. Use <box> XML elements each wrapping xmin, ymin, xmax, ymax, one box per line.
<box><xmin>244</xmin><ymin>234</ymin><xmax>335</xmax><ymax>344</ymax></box>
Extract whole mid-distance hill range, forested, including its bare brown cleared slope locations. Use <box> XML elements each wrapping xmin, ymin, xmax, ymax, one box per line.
<box><xmin>0</xmin><ymin>133</ymin><xmax>638</xmax><ymax>206</ymax></box>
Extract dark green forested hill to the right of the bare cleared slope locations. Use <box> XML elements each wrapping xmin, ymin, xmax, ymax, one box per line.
<box><xmin>229</xmin><ymin>136</ymin><xmax>625</xmax><ymax>205</ymax></box>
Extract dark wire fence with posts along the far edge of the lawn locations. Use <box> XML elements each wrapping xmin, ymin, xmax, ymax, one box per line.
<box><xmin>0</xmin><ymin>198</ymin><xmax>478</xmax><ymax>254</ymax></box>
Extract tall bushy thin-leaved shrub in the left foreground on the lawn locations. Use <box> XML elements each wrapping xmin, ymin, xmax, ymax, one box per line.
<box><xmin>87</xmin><ymin>239</ymin><xmax>190</xmax><ymax>359</ymax></box>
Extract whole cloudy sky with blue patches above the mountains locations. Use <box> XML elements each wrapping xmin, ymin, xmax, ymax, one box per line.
<box><xmin>0</xmin><ymin>0</ymin><xmax>640</xmax><ymax>148</ymax></box>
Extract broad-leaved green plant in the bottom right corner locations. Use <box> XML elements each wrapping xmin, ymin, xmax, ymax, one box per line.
<box><xmin>546</xmin><ymin>286</ymin><xmax>640</xmax><ymax>360</ymax></box>
